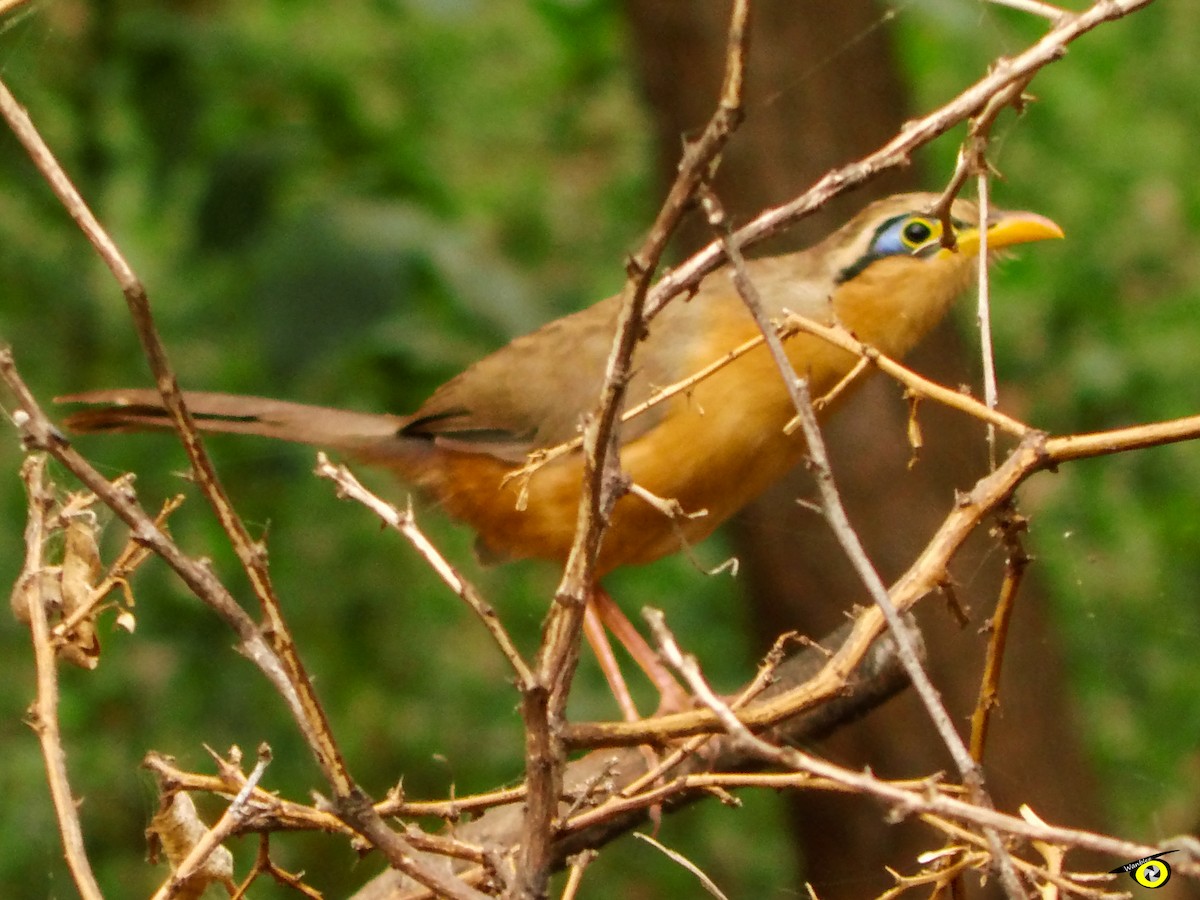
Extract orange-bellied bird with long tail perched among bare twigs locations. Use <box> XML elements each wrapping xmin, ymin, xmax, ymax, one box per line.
<box><xmin>58</xmin><ymin>193</ymin><xmax>1063</xmax><ymax>718</ymax></box>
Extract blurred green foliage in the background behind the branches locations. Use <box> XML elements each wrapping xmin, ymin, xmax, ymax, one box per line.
<box><xmin>0</xmin><ymin>0</ymin><xmax>1200</xmax><ymax>900</ymax></box>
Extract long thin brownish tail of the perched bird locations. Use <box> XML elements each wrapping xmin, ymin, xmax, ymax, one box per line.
<box><xmin>56</xmin><ymin>389</ymin><xmax>408</xmax><ymax>456</ymax></box>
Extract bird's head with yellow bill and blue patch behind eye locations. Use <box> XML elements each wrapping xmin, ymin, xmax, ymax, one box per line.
<box><xmin>820</xmin><ymin>193</ymin><xmax>1063</xmax><ymax>356</ymax></box>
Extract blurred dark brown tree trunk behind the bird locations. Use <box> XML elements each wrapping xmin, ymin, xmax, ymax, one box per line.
<box><xmin>626</xmin><ymin>0</ymin><xmax>1099</xmax><ymax>900</ymax></box>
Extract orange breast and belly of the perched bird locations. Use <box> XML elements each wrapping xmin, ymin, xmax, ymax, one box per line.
<box><xmin>388</xmin><ymin>300</ymin><xmax>854</xmax><ymax>575</ymax></box>
